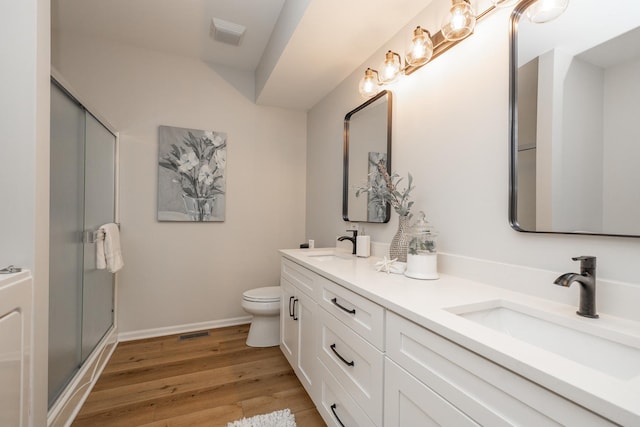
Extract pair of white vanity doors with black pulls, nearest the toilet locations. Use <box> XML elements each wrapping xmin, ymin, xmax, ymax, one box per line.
<box><xmin>280</xmin><ymin>260</ymin><xmax>320</xmax><ymax>400</ymax></box>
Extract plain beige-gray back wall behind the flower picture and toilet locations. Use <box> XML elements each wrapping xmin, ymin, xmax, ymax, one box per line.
<box><xmin>53</xmin><ymin>34</ymin><xmax>306</xmax><ymax>335</ymax></box>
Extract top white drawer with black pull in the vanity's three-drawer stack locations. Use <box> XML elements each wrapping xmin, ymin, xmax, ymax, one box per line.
<box><xmin>319</xmin><ymin>278</ymin><xmax>384</xmax><ymax>351</ymax></box>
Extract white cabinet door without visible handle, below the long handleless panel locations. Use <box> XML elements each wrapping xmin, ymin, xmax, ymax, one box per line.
<box><xmin>384</xmin><ymin>358</ymin><xmax>478</xmax><ymax>427</ymax></box>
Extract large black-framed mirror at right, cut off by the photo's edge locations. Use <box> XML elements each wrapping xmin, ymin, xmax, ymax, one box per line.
<box><xmin>509</xmin><ymin>0</ymin><xmax>640</xmax><ymax>236</ymax></box>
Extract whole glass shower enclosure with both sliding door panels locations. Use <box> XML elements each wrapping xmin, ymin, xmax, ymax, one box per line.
<box><xmin>48</xmin><ymin>78</ymin><xmax>117</xmax><ymax>409</ymax></box>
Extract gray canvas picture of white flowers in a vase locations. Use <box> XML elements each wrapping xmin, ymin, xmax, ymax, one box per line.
<box><xmin>158</xmin><ymin>126</ymin><xmax>227</xmax><ymax>222</ymax></box>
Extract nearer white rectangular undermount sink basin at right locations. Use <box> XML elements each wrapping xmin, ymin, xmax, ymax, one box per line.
<box><xmin>447</xmin><ymin>300</ymin><xmax>640</xmax><ymax>380</ymax></box>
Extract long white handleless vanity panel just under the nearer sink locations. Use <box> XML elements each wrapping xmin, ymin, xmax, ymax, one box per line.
<box><xmin>386</xmin><ymin>312</ymin><xmax>611</xmax><ymax>427</ymax></box>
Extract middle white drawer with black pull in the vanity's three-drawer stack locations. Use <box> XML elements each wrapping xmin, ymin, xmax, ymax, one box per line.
<box><xmin>318</xmin><ymin>309</ymin><xmax>384</xmax><ymax>424</ymax></box>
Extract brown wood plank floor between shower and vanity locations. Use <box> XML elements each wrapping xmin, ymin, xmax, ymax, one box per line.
<box><xmin>72</xmin><ymin>325</ymin><xmax>325</xmax><ymax>427</ymax></box>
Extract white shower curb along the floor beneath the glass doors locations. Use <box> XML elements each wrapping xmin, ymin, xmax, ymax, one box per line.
<box><xmin>47</xmin><ymin>328</ymin><xmax>118</xmax><ymax>427</ymax></box>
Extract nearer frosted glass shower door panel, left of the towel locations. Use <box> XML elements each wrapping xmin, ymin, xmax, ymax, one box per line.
<box><xmin>49</xmin><ymin>85</ymin><xmax>85</xmax><ymax>405</ymax></box>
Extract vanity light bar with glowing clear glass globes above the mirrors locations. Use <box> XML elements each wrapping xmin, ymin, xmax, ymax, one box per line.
<box><xmin>359</xmin><ymin>0</ymin><xmax>569</xmax><ymax>98</ymax></box>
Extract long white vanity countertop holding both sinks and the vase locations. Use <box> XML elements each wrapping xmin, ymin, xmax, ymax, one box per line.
<box><xmin>281</xmin><ymin>248</ymin><xmax>640</xmax><ymax>425</ymax></box>
